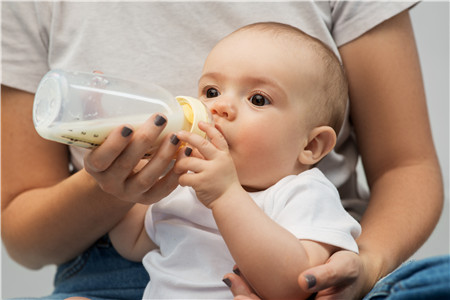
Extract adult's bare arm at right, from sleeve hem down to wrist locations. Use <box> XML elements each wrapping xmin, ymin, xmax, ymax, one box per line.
<box><xmin>339</xmin><ymin>12</ymin><xmax>443</xmax><ymax>292</ymax></box>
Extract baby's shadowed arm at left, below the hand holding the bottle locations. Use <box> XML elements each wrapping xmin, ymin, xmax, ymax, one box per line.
<box><xmin>109</xmin><ymin>204</ymin><xmax>157</xmax><ymax>261</ymax></box>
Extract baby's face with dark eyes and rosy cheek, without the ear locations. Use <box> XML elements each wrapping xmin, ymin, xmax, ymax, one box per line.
<box><xmin>199</xmin><ymin>30</ymin><xmax>317</xmax><ymax>190</ymax></box>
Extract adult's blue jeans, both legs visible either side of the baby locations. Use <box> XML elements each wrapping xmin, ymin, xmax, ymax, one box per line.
<box><xmin>9</xmin><ymin>240</ymin><xmax>450</xmax><ymax>300</ymax></box>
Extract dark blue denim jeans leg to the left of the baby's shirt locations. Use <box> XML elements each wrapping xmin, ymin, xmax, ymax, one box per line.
<box><xmin>9</xmin><ymin>236</ymin><xmax>150</xmax><ymax>300</ymax></box>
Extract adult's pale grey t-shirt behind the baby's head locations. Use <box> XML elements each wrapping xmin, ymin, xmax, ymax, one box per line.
<box><xmin>1</xmin><ymin>1</ymin><xmax>412</xmax><ymax>219</ymax></box>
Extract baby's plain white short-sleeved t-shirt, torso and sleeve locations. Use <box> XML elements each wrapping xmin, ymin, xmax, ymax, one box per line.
<box><xmin>143</xmin><ymin>168</ymin><xmax>361</xmax><ymax>299</ymax></box>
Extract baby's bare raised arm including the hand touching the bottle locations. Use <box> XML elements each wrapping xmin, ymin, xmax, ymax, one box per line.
<box><xmin>175</xmin><ymin>124</ymin><xmax>335</xmax><ymax>299</ymax></box>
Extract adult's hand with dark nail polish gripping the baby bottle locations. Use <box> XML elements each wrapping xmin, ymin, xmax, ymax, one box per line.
<box><xmin>84</xmin><ymin>114</ymin><xmax>179</xmax><ymax>204</ymax></box>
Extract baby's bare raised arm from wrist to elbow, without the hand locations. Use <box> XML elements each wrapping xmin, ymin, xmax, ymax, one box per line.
<box><xmin>212</xmin><ymin>186</ymin><xmax>336</xmax><ymax>299</ymax></box>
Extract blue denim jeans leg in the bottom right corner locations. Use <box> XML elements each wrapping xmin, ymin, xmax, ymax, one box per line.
<box><xmin>363</xmin><ymin>255</ymin><xmax>450</xmax><ymax>300</ymax></box>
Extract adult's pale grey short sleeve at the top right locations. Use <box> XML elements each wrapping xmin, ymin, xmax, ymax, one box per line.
<box><xmin>331</xmin><ymin>1</ymin><xmax>417</xmax><ymax>47</ymax></box>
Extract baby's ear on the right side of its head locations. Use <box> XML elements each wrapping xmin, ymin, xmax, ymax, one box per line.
<box><xmin>298</xmin><ymin>126</ymin><xmax>336</xmax><ymax>166</ymax></box>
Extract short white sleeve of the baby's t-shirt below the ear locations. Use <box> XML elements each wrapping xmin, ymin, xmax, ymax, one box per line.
<box><xmin>273</xmin><ymin>170</ymin><xmax>361</xmax><ymax>253</ymax></box>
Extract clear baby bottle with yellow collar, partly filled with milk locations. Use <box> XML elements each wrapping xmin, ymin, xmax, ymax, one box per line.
<box><xmin>33</xmin><ymin>70</ymin><xmax>212</xmax><ymax>156</ymax></box>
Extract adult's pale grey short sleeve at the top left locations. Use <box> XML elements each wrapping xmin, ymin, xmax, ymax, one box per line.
<box><xmin>2</xmin><ymin>1</ymin><xmax>52</xmax><ymax>93</ymax></box>
